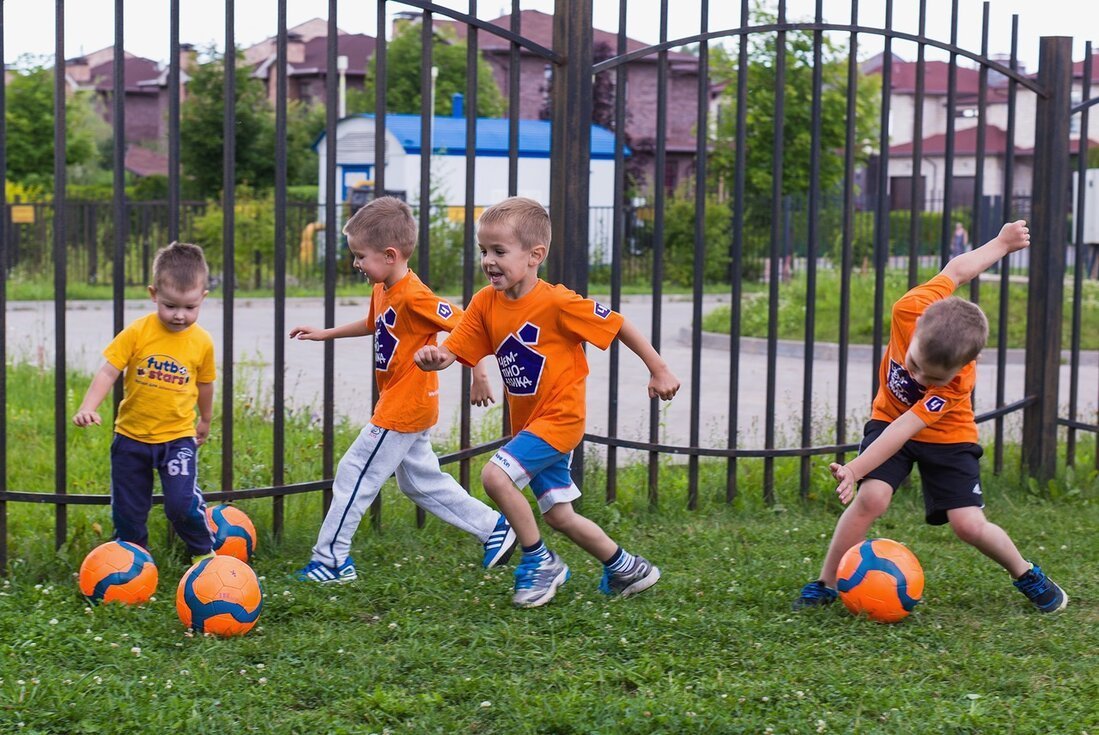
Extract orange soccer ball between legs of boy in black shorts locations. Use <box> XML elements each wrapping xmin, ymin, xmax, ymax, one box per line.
<box><xmin>836</xmin><ymin>538</ymin><xmax>923</xmax><ymax>623</ymax></box>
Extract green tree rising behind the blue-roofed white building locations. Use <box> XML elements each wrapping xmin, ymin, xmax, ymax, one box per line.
<box><xmin>347</xmin><ymin>22</ymin><xmax>506</xmax><ymax>118</ymax></box>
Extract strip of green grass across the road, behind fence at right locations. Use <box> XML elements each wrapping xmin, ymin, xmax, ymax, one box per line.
<box><xmin>702</xmin><ymin>270</ymin><xmax>1099</xmax><ymax>349</ymax></box>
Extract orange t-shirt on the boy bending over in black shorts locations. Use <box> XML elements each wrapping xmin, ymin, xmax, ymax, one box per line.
<box><xmin>870</xmin><ymin>274</ymin><xmax>977</xmax><ymax>444</ymax></box>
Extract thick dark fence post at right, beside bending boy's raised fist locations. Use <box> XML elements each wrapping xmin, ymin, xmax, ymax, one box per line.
<box><xmin>1023</xmin><ymin>36</ymin><xmax>1073</xmax><ymax>479</ymax></box>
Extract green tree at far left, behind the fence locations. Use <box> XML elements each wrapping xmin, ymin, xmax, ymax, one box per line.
<box><xmin>5</xmin><ymin>63</ymin><xmax>96</xmax><ymax>188</ymax></box>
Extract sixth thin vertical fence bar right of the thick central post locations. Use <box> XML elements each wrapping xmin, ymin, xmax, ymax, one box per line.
<box><xmin>800</xmin><ymin>0</ymin><xmax>824</xmax><ymax>500</ymax></box>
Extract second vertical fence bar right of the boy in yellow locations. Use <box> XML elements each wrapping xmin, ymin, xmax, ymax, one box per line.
<box><xmin>271</xmin><ymin>0</ymin><xmax>289</xmax><ymax>537</ymax></box>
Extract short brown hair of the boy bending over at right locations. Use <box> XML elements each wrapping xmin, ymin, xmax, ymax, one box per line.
<box><xmin>915</xmin><ymin>297</ymin><xmax>988</xmax><ymax>370</ymax></box>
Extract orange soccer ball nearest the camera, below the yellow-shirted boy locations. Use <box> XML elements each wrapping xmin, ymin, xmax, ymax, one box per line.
<box><xmin>176</xmin><ymin>556</ymin><xmax>264</xmax><ymax>636</ymax></box>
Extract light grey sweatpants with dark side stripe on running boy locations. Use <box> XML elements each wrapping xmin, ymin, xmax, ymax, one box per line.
<box><xmin>313</xmin><ymin>424</ymin><xmax>499</xmax><ymax>567</ymax></box>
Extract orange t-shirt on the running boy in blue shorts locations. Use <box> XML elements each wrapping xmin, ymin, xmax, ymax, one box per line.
<box><xmin>444</xmin><ymin>279</ymin><xmax>622</xmax><ymax>452</ymax></box>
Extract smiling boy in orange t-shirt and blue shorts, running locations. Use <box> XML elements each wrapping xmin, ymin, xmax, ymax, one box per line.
<box><xmin>415</xmin><ymin>197</ymin><xmax>679</xmax><ymax>608</ymax></box>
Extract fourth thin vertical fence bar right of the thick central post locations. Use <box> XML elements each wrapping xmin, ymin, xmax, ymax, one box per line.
<box><xmin>725</xmin><ymin>0</ymin><xmax>751</xmax><ymax>503</ymax></box>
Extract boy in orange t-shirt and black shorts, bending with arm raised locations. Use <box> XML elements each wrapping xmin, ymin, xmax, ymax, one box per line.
<box><xmin>793</xmin><ymin>220</ymin><xmax>1068</xmax><ymax>612</ymax></box>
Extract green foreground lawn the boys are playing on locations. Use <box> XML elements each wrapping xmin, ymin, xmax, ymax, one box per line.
<box><xmin>0</xmin><ymin>368</ymin><xmax>1099</xmax><ymax>734</ymax></box>
